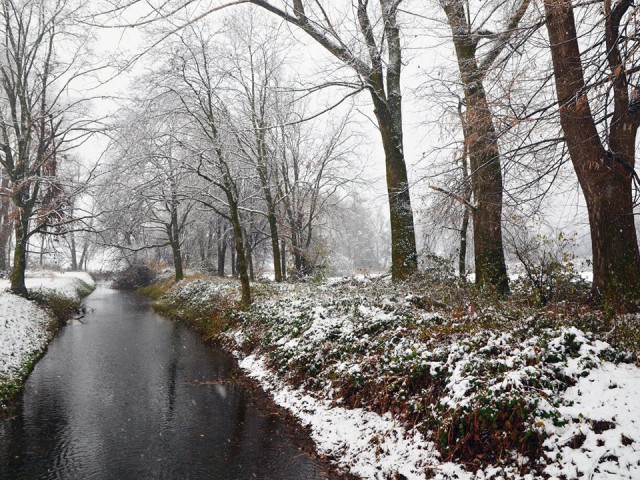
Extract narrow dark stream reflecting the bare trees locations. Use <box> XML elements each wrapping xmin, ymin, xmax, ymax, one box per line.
<box><xmin>0</xmin><ymin>288</ymin><xmax>324</xmax><ymax>480</ymax></box>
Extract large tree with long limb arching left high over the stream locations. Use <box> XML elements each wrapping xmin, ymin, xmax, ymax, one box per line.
<box><xmin>103</xmin><ymin>0</ymin><xmax>417</xmax><ymax>280</ymax></box>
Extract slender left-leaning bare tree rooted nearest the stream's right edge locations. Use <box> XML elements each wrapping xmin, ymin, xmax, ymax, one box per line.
<box><xmin>155</xmin><ymin>25</ymin><xmax>251</xmax><ymax>306</ymax></box>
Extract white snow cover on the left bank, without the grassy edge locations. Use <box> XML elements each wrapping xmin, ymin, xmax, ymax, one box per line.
<box><xmin>0</xmin><ymin>271</ymin><xmax>94</xmax><ymax>408</ymax></box>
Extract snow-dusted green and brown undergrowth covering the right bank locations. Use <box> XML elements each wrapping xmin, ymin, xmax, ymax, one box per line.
<box><xmin>148</xmin><ymin>275</ymin><xmax>640</xmax><ymax>473</ymax></box>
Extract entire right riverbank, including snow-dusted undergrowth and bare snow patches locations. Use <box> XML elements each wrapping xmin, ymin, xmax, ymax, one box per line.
<box><xmin>149</xmin><ymin>278</ymin><xmax>640</xmax><ymax>479</ymax></box>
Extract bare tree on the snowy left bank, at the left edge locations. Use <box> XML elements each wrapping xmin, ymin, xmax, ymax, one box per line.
<box><xmin>0</xmin><ymin>0</ymin><xmax>96</xmax><ymax>296</ymax></box>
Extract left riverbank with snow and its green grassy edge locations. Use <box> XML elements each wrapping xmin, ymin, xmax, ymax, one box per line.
<box><xmin>0</xmin><ymin>272</ymin><xmax>95</xmax><ymax>412</ymax></box>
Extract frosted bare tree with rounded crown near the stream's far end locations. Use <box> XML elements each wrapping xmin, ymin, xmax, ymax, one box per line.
<box><xmin>103</xmin><ymin>104</ymin><xmax>195</xmax><ymax>281</ymax></box>
